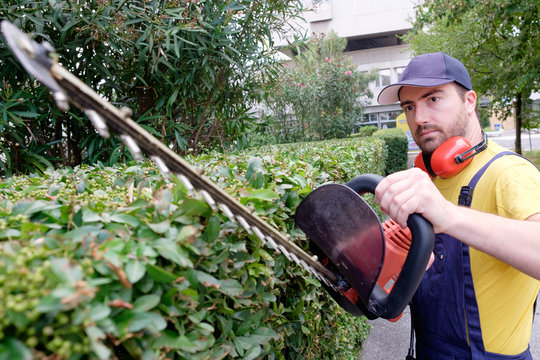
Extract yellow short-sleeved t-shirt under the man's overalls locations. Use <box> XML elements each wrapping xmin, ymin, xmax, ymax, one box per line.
<box><xmin>434</xmin><ymin>140</ymin><xmax>540</xmax><ymax>355</ymax></box>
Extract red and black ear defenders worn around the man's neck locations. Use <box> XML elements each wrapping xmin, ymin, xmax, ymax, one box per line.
<box><xmin>414</xmin><ymin>133</ymin><xmax>487</xmax><ymax>179</ymax></box>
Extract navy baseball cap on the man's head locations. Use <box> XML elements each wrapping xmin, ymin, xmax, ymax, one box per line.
<box><xmin>377</xmin><ymin>52</ymin><xmax>472</xmax><ymax>105</ymax></box>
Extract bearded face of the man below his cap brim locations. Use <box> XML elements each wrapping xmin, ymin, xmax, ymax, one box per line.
<box><xmin>399</xmin><ymin>83</ymin><xmax>476</xmax><ymax>154</ymax></box>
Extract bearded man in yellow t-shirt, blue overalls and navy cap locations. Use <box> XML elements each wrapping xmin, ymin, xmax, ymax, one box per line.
<box><xmin>375</xmin><ymin>53</ymin><xmax>540</xmax><ymax>359</ymax></box>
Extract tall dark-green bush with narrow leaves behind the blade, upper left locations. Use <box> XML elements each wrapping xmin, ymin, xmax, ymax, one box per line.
<box><xmin>0</xmin><ymin>0</ymin><xmax>301</xmax><ymax>175</ymax></box>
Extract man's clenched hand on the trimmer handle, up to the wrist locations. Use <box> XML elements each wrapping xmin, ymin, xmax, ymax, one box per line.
<box><xmin>375</xmin><ymin>168</ymin><xmax>455</xmax><ymax>233</ymax></box>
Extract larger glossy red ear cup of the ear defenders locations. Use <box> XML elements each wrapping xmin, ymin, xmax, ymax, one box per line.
<box><xmin>431</xmin><ymin>136</ymin><xmax>472</xmax><ymax>178</ymax></box>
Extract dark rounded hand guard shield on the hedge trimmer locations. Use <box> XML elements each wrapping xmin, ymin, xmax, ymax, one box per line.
<box><xmin>295</xmin><ymin>184</ymin><xmax>385</xmax><ymax>304</ymax></box>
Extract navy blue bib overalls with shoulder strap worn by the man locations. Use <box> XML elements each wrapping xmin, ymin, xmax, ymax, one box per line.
<box><xmin>411</xmin><ymin>152</ymin><xmax>532</xmax><ymax>360</ymax></box>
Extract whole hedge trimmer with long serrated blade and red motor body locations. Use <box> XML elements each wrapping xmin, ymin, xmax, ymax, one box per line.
<box><xmin>1</xmin><ymin>21</ymin><xmax>433</xmax><ymax>319</ymax></box>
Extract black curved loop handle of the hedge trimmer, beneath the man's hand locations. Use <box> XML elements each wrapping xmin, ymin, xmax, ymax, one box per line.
<box><xmin>345</xmin><ymin>174</ymin><xmax>435</xmax><ymax>319</ymax></box>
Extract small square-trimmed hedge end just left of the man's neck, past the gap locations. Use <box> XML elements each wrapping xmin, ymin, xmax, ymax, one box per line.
<box><xmin>373</xmin><ymin>128</ymin><xmax>409</xmax><ymax>175</ymax></box>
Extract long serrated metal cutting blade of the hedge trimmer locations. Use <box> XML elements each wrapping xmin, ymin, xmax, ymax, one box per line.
<box><xmin>1</xmin><ymin>21</ymin><xmax>337</xmax><ymax>287</ymax></box>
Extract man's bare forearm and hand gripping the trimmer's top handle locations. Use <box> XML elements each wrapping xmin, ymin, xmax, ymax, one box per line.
<box><xmin>375</xmin><ymin>168</ymin><xmax>540</xmax><ymax>280</ymax></box>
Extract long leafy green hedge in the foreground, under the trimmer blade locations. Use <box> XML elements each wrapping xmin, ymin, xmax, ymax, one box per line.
<box><xmin>0</xmin><ymin>139</ymin><xmax>385</xmax><ymax>360</ymax></box>
